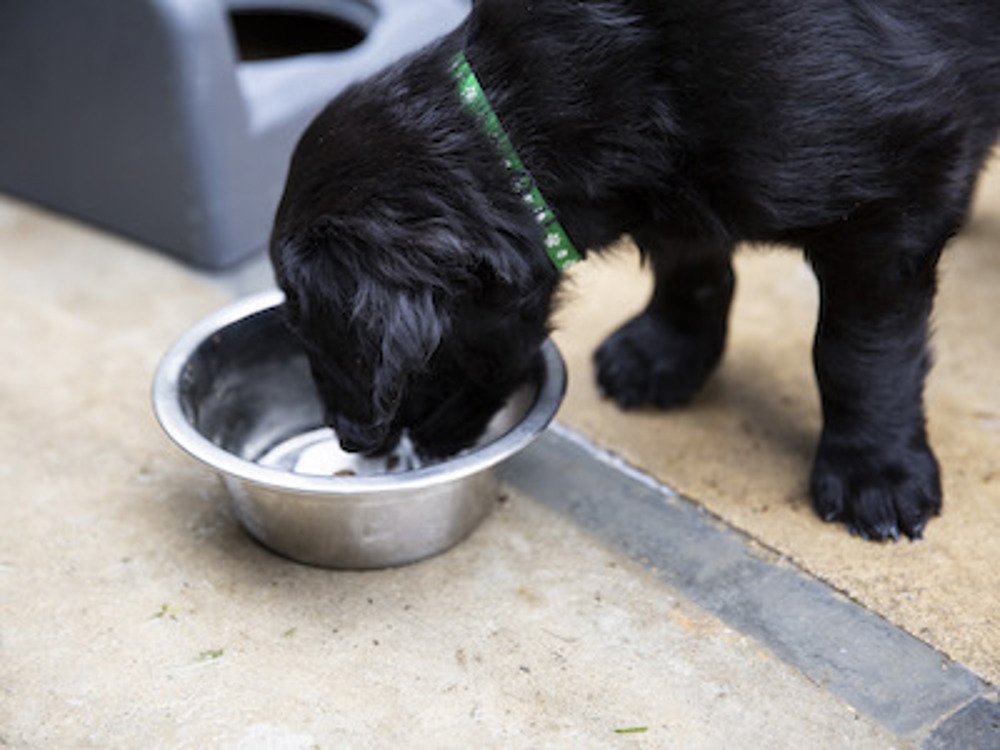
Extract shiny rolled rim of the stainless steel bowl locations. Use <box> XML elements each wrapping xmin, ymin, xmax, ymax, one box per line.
<box><xmin>152</xmin><ymin>290</ymin><xmax>566</xmax><ymax>500</ymax></box>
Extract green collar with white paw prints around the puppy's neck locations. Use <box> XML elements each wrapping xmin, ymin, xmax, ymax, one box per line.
<box><xmin>452</xmin><ymin>52</ymin><xmax>580</xmax><ymax>271</ymax></box>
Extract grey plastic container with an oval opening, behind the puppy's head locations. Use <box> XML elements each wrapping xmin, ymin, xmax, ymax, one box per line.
<box><xmin>0</xmin><ymin>0</ymin><xmax>470</xmax><ymax>268</ymax></box>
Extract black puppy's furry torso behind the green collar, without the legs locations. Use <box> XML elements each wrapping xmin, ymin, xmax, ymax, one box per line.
<box><xmin>470</xmin><ymin>0</ymin><xmax>1000</xmax><ymax>245</ymax></box>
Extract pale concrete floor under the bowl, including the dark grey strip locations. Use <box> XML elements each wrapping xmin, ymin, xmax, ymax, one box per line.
<box><xmin>0</xmin><ymin>189</ymin><xmax>1000</xmax><ymax>748</ymax></box>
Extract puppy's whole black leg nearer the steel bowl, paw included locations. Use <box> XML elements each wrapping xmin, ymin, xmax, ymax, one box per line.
<box><xmin>594</xmin><ymin>232</ymin><xmax>735</xmax><ymax>409</ymax></box>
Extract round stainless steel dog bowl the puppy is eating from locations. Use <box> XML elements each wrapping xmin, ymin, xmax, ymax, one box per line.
<box><xmin>153</xmin><ymin>292</ymin><xmax>566</xmax><ymax>568</ymax></box>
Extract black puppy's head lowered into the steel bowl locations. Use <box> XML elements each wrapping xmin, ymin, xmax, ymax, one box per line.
<box><xmin>271</xmin><ymin>79</ymin><xmax>557</xmax><ymax>456</ymax></box>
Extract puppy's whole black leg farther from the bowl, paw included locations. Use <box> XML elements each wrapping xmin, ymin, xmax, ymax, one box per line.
<box><xmin>810</xmin><ymin>241</ymin><xmax>941</xmax><ymax>540</ymax></box>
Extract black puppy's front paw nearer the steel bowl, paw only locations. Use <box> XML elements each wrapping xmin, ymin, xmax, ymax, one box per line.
<box><xmin>594</xmin><ymin>312</ymin><xmax>725</xmax><ymax>409</ymax></box>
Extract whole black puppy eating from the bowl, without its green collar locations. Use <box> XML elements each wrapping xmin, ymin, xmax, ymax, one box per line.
<box><xmin>272</xmin><ymin>0</ymin><xmax>1000</xmax><ymax>539</ymax></box>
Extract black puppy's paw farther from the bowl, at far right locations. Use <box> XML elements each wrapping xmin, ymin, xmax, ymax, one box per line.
<box><xmin>811</xmin><ymin>440</ymin><xmax>941</xmax><ymax>541</ymax></box>
